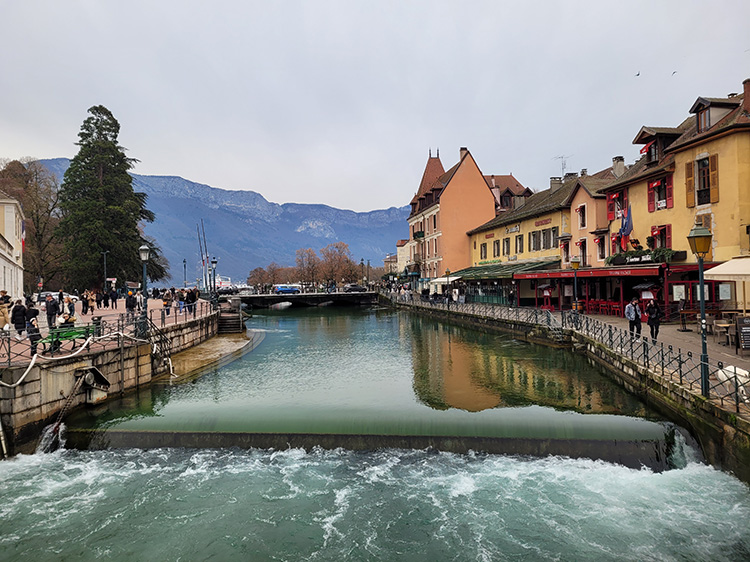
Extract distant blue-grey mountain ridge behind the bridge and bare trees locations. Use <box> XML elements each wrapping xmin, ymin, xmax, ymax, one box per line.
<box><xmin>41</xmin><ymin>158</ymin><xmax>409</xmax><ymax>283</ymax></box>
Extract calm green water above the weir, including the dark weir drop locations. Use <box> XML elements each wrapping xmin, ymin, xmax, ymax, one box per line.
<box><xmin>60</xmin><ymin>308</ymin><xmax>690</xmax><ymax>471</ymax></box>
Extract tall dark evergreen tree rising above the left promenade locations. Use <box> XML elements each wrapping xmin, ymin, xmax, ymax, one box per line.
<box><xmin>57</xmin><ymin>105</ymin><xmax>168</xmax><ymax>290</ymax></box>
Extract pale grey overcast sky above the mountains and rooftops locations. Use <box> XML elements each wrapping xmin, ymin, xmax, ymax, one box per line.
<box><xmin>0</xmin><ymin>0</ymin><xmax>750</xmax><ymax>211</ymax></box>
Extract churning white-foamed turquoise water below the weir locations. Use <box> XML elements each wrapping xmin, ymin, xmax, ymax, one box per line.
<box><xmin>0</xmin><ymin>449</ymin><xmax>750</xmax><ymax>561</ymax></box>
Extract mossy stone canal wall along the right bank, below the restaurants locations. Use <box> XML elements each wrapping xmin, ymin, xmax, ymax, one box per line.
<box><xmin>390</xmin><ymin>296</ymin><xmax>750</xmax><ymax>483</ymax></box>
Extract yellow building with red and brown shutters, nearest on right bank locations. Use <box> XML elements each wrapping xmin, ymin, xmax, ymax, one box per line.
<box><xmin>605</xmin><ymin>80</ymin><xmax>750</xmax><ymax>312</ymax></box>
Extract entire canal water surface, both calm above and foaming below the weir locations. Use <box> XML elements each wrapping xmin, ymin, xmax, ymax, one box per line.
<box><xmin>0</xmin><ymin>308</ymin><xmax>750</xmax><ymax>561</ymax></box>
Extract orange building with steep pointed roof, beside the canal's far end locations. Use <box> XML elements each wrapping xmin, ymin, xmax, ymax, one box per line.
<box><xmin>407</xmin><ymin>148</ymin><xmax>496</xmax><ymax>288</ymax></box>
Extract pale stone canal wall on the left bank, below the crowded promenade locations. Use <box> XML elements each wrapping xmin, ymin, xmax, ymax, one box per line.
<box><xmin>0</xmin><ymin>312</ymin><xmax>219</xmax><ymax>453</ymax></box>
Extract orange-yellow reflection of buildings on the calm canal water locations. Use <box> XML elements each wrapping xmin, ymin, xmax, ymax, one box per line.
<box><xmin>410</xmin><ymin>321</ymin><xmax>645</xmax><ymax>415</ymax></box>
